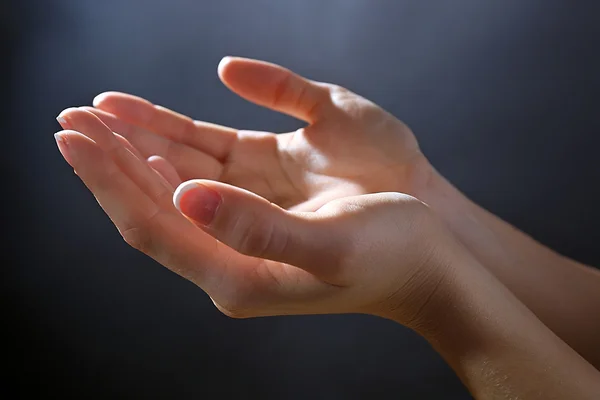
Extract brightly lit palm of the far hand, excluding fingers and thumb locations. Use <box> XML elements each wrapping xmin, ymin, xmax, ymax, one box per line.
<box><xmin>219</xmin><ymin>90</ymin><xmax>422</xmax><ymax>211</ymax></box>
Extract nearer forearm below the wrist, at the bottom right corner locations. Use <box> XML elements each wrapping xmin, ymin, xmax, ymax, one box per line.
<box><xmin>408</xmin><ymin>260</ymin><xmax>600</xmax><ymax>400</ymax></box>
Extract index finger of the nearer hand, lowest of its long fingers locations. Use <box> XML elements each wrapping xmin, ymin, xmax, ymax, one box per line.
<box><xmin>55</xmin><ymin>130</ymin><xmax>230</xmax><ymax>284</ymax></box>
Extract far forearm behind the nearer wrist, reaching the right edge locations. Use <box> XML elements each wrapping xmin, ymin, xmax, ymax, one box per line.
<box><xmin>417</xmin><ymin>165</ymin><xmax>600</xmax><ymax>367</ymax></box>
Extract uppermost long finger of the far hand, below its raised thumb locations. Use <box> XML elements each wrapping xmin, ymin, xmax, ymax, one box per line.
<box><xmin>94</xmin><ymin>92</ymin><xmax>236</xmax><ymax>160</ymax></box>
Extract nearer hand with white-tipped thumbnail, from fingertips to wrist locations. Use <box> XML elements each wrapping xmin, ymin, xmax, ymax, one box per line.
<box><xmin>57</xmin><ymin>109</ymin><xmax>461</xmax><ymax>326</ymax></box>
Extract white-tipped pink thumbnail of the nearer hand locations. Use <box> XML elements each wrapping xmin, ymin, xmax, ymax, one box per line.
<box><xmin>173</xmin><ymin>182</ymin><xmax>223</xmax><ymax>225</ymax></box>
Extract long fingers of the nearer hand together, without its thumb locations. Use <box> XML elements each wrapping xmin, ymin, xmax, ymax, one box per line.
<box><xmin>55</xmin><ymin>109</ymin><xmax>235</xmax><ymax>284</ymax></box>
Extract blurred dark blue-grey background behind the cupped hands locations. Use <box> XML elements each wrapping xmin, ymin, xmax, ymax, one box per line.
<box><xmin>0</xmin><ymin>0</ymin><xmax>600</xmax><ymax>399</ymax></box>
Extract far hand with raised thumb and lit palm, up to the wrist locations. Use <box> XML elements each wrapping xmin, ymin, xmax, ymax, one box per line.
<box><xmin>88</xmin><ymin>57</ymin><xmax>430</xmax><ymax>211</ymax></box>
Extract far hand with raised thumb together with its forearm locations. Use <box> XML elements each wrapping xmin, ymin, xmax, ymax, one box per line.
<box><xmin>85</xmin><ymin>59</ymin><xmax>600</xmax><ymax>367</ymax></box>
